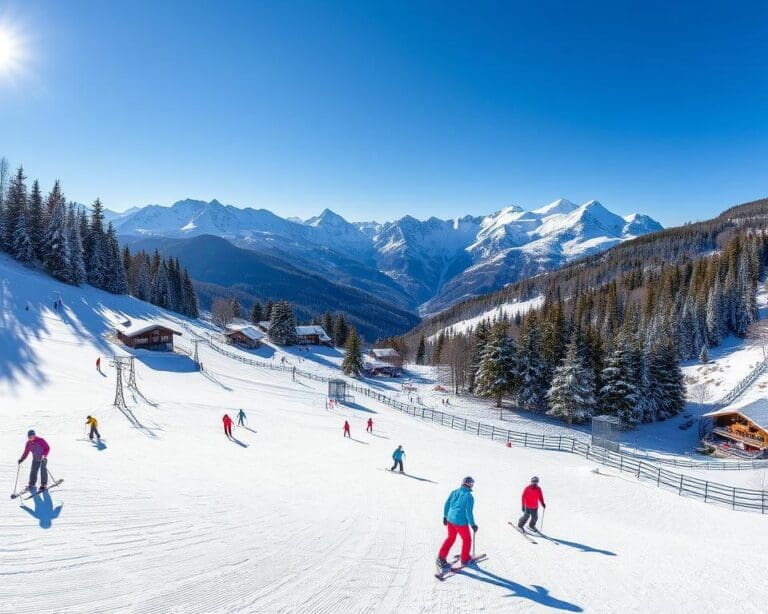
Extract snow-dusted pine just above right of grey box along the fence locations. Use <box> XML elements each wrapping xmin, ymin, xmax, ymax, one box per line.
<box><xmin>600</xmin><ymin>335</ymin><xmax>642</xmax><ymax>429</ymax></box>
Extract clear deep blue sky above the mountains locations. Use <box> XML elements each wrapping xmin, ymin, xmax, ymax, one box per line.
<box><xmin>0</xmin><ymin>0</ymin><xmax>768</xmax><ymax>225</ymax></box>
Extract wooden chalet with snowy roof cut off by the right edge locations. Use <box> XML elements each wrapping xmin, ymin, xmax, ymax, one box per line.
<box><xmin>702</xmin><ymin>399</ymin><xmax>768</xmax><ymax>458</ymax></box>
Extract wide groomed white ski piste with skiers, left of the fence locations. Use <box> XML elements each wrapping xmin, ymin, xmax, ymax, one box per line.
<box><xmin>0</xmin><ymin>257</ymin><xmax>768</xmax><ymax>614</ymax></box>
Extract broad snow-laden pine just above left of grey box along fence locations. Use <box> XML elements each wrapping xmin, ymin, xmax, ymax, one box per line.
<box><xmin>547</xmin><ymin>334</ymin><xmax>597</xmax><ymax>424</ymax></box>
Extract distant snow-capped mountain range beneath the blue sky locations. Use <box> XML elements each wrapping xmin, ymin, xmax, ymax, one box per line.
<box><xmin>106</xmin><ymin>199</ymin><xmax>662</xmax><ymax>314</ymax></box>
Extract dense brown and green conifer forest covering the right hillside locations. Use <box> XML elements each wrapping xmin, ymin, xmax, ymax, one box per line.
<box><xmin>392</xmin><ymin>201</ymin><xmax>768</xmax><ymax>428</ymax></box>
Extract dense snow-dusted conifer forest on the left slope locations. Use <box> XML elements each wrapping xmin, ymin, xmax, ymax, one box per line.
<box><xmin>0</xmin><ymin>158</ymin><xmax>198</xmax><ymax>317</ymax></box>
